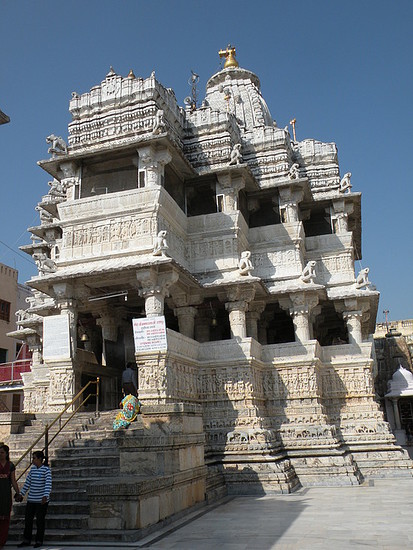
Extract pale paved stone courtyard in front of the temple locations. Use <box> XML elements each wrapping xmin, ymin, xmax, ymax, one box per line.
<box><xmin>7</xmin><ymin>479</ymin><xmax>413</xmax><ymax>550</ymax></box>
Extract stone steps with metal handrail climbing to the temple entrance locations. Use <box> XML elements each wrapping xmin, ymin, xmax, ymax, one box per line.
<box><xmin>9</xmin><ymin>411</ymin><xmax>139</xmax><ymax>542</ymax></box>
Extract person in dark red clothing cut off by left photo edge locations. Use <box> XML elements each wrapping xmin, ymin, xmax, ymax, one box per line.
<box><xmin>0</xmin><ymin>443</ymin><xmax>19</xmax><ymax>548</ymax></box>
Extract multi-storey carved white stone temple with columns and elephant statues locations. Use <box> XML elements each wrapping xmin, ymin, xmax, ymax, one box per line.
<box><xmin>8</xmin><ymin>49</ymin><xmax>411</xmax><ymax>493</ymax></box>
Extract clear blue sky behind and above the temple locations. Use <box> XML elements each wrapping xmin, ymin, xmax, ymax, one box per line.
<box><xmin>0</xmin><ymin>0</ymin><xmax>413</xmax><ymax>321</ymax></box>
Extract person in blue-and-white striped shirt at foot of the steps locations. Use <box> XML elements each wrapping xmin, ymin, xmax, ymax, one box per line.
<box><xmin>16</xmin><ymin>451</ymin><xmax>52</xmax><ymax>548</ymax></box>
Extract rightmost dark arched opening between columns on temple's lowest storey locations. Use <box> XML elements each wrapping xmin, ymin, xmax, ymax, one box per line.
<box><xmin>313</xmin><ymin>302</ymin><xmax>348</xmax><ymax>346</ymax></box>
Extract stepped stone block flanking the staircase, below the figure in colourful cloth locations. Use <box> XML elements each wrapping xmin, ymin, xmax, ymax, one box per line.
<box><xmin>88</xmin><ymin>403</ymin><xmax>207</xmax><ymax>531</ymax></box>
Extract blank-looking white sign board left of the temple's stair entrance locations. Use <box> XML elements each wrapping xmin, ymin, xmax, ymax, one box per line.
<box><xmin>43</xmin><ymin>315</ymin><xmax>71</xmax><ymax>360</ymax></box>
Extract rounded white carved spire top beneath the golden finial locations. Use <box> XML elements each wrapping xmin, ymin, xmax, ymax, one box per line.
<box><xmin>205</xmin><ymin>67</ymin><xmax>274</xmax><ymax>130</ymax></box>
